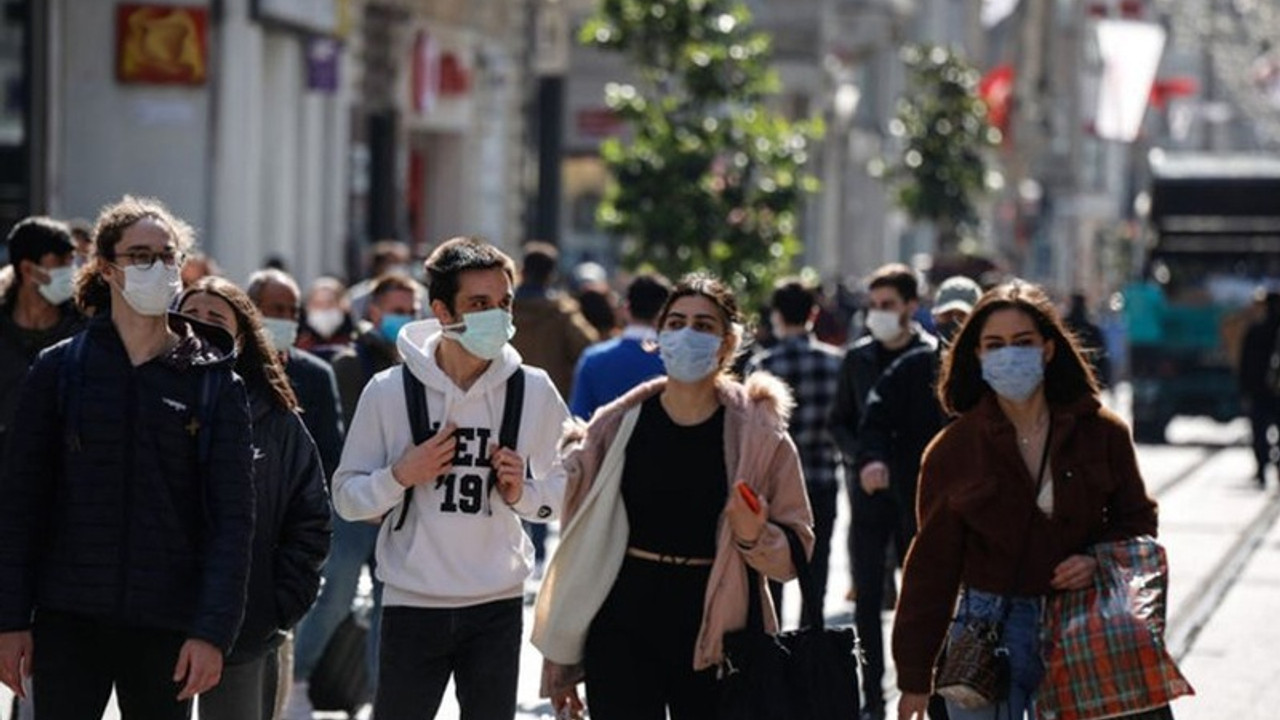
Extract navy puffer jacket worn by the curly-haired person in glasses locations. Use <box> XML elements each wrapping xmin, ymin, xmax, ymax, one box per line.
<box><xmin>0</xmin><ymin>315</ymin><xmax>253</xmax><ymax>651</ymax></box>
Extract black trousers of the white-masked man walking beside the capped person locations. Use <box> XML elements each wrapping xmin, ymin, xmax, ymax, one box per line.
<box><xmin>851</xmin><ymin>487</ymin><xmax>911</xmax><ymax>711</ymax></box>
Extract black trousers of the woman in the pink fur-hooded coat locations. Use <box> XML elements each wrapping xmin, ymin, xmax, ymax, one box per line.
<box><xmin>583</xmin><ymin>557</ymin><xmax>718</xmax><ymax>720</ymax></box>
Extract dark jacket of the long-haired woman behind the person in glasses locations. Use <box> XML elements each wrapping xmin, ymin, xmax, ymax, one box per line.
<box><xmin>227</xmin><ymin>391</ymin><xmax>330</xmax><ymax>665</ymax></box>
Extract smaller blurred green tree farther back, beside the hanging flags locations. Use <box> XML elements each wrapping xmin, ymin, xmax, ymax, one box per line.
<box><xmin>887</xmin><ymin>46</ymin><xmax>1000</xmax><ymax>259</ymax></box>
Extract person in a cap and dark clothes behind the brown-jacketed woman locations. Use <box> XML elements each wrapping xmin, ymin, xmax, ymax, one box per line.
<box><xmin>854</xmin><ymin>275</ymin><xmax>982</xmax><ymax>720</ymax></box>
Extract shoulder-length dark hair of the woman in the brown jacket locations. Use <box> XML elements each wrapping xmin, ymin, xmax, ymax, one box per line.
<box><xmin>938</xmin><ymin>281</ymin><xmax>1098</xmax><ymax>415</ymax></box>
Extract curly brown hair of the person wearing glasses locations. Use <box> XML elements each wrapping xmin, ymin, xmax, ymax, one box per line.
<box><xmin>76</xmin><ymin>195</ymin><xmax>196</xmax><ymax>314</ymax></box>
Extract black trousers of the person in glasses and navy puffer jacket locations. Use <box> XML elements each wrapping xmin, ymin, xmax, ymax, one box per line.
<box><xmin>32</xmin><ymin>610</ymin><xmax>191</xmax><ymax>720</ymax></box>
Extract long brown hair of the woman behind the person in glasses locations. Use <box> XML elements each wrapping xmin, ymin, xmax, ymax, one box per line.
<box><xmin>177</xmin><ymin>275</ymin><xmax>298</xmax><ymax>410</ymax></box>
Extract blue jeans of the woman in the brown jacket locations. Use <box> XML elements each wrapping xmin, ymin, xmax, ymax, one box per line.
<box><xmin>947</xmin><ymin>589</ymin><xmax>1044</xmax><ymax>720</ymax></box>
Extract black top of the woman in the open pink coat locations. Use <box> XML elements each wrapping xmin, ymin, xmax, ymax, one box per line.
<box><xmin>622</xmin><ymin>395</ymin><xmax>728</xmax><ymax>557</ymax></box>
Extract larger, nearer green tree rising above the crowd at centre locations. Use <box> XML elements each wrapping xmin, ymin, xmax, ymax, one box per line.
<box><xmin>580</xmin><ymin>0</ymin><xmax>822</xmax><ymax>301</ymax></box>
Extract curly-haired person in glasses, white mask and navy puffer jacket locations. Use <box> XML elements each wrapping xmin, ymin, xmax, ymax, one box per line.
<box><xmin>0</xmin><ymin>196</ymin><xmax>255</xmax><ymax>720</ymax></box>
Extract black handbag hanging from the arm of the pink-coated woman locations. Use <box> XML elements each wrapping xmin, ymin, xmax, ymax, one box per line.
<box><xmin>719</xmin><ymin>525</ymin><xmax>859</xmax><ymax>720</ymax></box>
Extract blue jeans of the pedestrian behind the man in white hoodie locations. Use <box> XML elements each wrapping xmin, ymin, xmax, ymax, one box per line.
<box><xmin>293</xmin><ymin>515</ymin><xmax>383</xmax><ymax>682</ymax></box>
